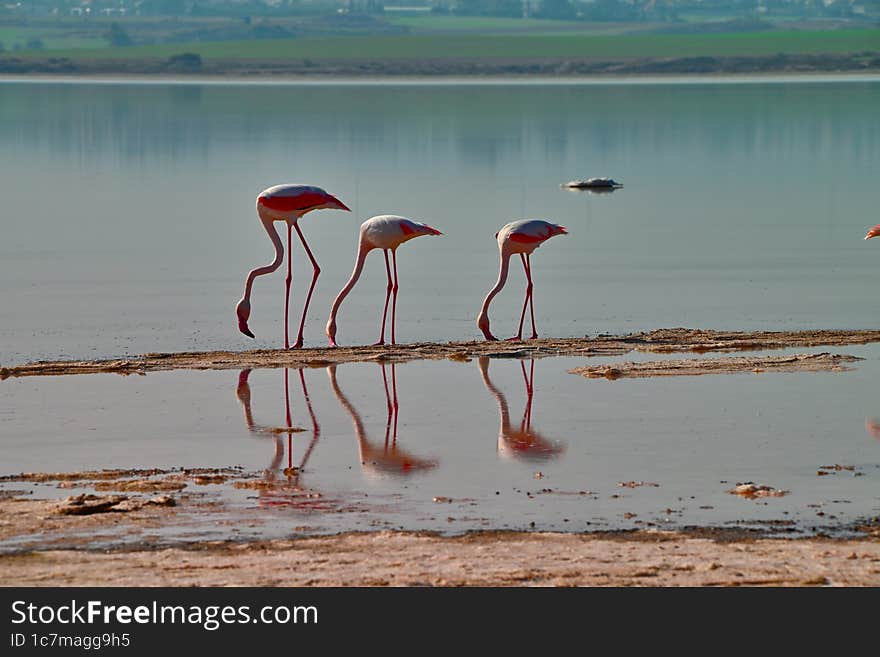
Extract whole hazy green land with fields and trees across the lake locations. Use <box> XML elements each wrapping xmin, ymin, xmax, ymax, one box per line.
<box><xmin>0</xmin><ymin>0</ymin><xmax>880</xmax><ymax>74</ymax></box>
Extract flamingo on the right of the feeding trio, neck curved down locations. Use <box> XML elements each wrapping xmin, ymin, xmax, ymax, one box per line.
<box><xmin>477</xmin><ymin>219</ymin><xmax>568</xmax><ymax>340</ymax></box>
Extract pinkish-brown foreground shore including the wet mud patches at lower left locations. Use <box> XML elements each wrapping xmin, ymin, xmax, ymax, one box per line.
<box><xmin>0</xmin><ymin>471</ymin><xmax>880</xmax><ymax>586</ymax></box>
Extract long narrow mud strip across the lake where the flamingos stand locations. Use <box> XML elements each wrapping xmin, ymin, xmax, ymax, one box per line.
<box><xmin>0</xmin><ymin>328</ymin><xmax>880</xmax><ymax>379</ymax></box>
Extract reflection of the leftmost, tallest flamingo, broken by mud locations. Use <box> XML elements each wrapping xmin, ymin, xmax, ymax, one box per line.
<box><xmin>235</xmin><ymin>368</ymin><xmax>332</xmax><ymax>510</ymax></box>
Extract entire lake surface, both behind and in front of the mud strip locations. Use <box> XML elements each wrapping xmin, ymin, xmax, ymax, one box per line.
<box><xmin>0</xmin><ymin>79</ymin><xmax>880</xmax><ymax>538</ymax></box>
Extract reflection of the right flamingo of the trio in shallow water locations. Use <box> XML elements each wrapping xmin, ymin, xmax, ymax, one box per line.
<box><xmin>477</xmin><ymin>356</ymin><xmax>565</xmax><ymax>461</ymax></box>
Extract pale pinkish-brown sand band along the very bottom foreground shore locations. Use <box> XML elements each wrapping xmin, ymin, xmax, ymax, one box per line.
<box><xmin>0</xmin><ymin>532</ymin><xmax>880</xmax><ymax>586</ymax></box>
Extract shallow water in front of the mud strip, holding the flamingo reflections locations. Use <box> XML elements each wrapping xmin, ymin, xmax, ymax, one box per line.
<box><xmin>0</xmin><ymin>346</ymin><xmax>880</xmax><ymax>538</ymax></box>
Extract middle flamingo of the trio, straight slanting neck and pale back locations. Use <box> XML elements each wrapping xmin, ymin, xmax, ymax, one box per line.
<box><xmin>326</xmin><ymin>214</ymin><xmax>443</xmax><ymax>347</ymax></box>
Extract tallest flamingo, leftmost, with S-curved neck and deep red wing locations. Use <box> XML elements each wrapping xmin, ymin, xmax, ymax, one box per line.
<box><xmin>241</xmin><ymin>185</ymin><xmax>351</xmax><ymax>349</ymax></box>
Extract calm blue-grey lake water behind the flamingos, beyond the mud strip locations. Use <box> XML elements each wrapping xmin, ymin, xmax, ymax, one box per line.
<box><xmin>0</xmin><ymin>81</ymin><xmax>880</xmax><ymax>364</ymax></box>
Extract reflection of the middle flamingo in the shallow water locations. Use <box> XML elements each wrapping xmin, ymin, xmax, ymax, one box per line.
<box><xmin>327</xmin><ymin>363</ymin><xmax>437</xmax><ymax>476</ymax></box>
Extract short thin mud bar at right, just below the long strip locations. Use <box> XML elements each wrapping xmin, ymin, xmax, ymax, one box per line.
<box><xmin>569</xmin><ymin>352</ymin><xmax>864</xmax><ymax>380</ymax></box>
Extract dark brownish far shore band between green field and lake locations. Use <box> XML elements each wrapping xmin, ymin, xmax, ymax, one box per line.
<box><xmin>0</xmin><ymin>51</ymin><xmax>880</xmax><ymax>80</ymax></box>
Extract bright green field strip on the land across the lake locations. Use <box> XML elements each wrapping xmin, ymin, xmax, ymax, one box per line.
<box><xmin>17</xmin><ymin>29</ymin><xmax>880</xmax><ymax>61</ymax></box>
